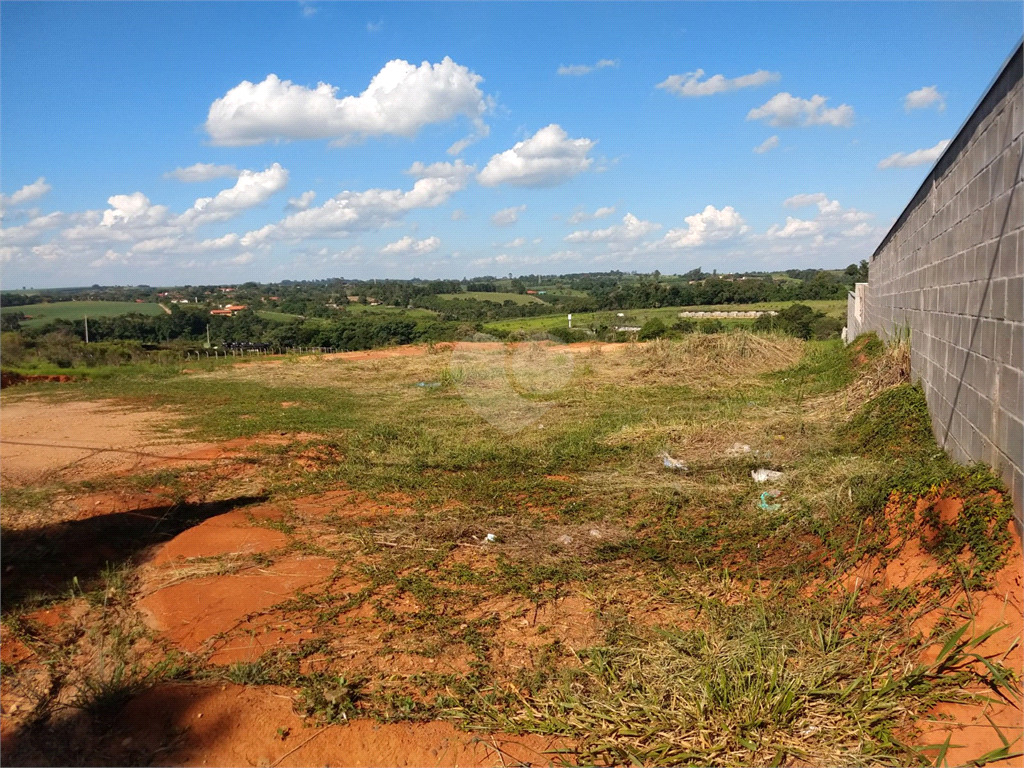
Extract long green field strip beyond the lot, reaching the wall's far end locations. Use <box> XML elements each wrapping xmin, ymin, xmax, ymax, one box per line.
<box><xmin>484</xmin><ymin>299</ymin><xmax>846</xmax><ymax>333</ymax></box>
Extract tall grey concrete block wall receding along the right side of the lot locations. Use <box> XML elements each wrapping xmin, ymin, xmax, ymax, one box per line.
<box><xmin>847</xmin><ymin>40</ymin><xmax>1024</xmax><ymax>528</ymax></box>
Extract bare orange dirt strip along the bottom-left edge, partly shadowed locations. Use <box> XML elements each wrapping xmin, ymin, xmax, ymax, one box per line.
<box><xmin>4</xmin><ymin>684</ymin><xmax>566</xmax><ymax>768</ymax></box>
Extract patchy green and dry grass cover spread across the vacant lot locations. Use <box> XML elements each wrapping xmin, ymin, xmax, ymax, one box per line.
<box><xmin>3</xmin><ymin>334</ymin><xmax>1018</xmax><ymax>765</ymax></box>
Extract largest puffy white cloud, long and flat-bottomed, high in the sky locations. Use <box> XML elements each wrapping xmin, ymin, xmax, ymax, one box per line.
<box><xmin>206</xmin><ymin>56</ymin><xmax>492</xmax><ymax>145</ymax></box>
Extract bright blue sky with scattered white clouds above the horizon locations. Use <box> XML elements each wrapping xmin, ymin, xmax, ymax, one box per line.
<box><xmin>0</xmin><ymin>1</ymin><xmax>1024</xmax><ymax>289</ymax></box>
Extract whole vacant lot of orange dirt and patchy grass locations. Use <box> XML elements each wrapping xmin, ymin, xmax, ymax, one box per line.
<box><xmin>0</xmin><ymin>345</ymin><xmax>1024</xmax><ymax>766</ymax></box>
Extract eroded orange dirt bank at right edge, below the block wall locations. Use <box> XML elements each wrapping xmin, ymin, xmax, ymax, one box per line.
<box><xmin>842</xmin><ymin>489</ymin><xmax>1024</xmax><ymax>766</ymax></box>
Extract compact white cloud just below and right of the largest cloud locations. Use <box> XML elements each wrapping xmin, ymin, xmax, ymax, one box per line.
<box><xmin>476</xmin><ymin>123</ymin><xmax>596</xmax><ymax>186</ymax></box>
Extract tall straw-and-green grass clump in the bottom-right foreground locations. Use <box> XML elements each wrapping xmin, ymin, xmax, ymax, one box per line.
<box><xmin>452</xmin><ymin>588</ymin><xmax>999</xmax><ymax>766</ymax></box>
